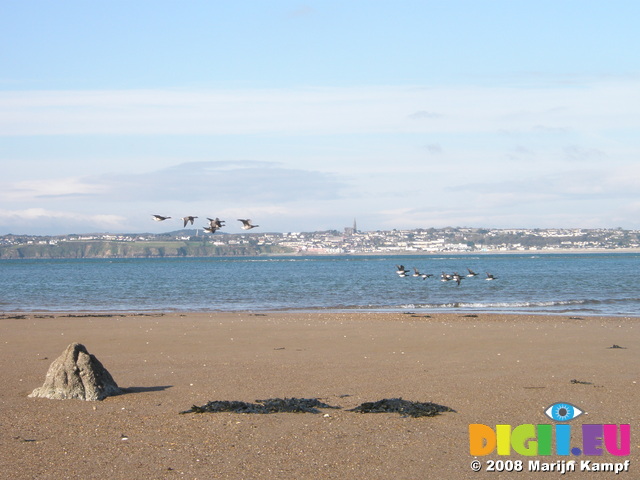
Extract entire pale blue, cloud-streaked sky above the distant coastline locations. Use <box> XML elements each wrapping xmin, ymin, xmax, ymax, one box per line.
<box><xmin>0</xmin><ymin>0</ymin><xmax>640</xmax><ymax>235</ymax></box>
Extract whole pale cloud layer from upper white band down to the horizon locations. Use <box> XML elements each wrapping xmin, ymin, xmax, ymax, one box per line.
<box><xmin>0</xmin><ymin>79</ymin><xmax>640</xmax><ymax>231</ymax></box>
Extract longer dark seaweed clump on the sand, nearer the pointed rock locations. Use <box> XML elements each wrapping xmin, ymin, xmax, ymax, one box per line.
<box><xmin>180</xmin><ymin>398</ymin><xmax>340</xmax><ymax>414</ymax></box>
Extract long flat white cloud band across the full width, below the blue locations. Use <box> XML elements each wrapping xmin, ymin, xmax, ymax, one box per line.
<box><xmin>0</xmin><ymin>79</ymin><xmax>640</xmax><ymax>135</ymax></box>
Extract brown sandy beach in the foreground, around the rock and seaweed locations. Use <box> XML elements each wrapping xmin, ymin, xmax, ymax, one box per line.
<box><xmin>0</xmin><ymin>313</ymin><xmax>640</xmax><ymax>479</ymax></box>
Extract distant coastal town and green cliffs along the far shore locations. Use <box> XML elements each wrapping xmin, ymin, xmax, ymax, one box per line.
<box><xmin>0</xmin><ymin>222</ymin><xmax>640</xmax><ymax>259</ymax></box>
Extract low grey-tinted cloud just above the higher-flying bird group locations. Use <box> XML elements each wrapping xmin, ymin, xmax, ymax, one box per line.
<box><xmin>0</xmin><ymin>161</ymin><xmax>346</xmax><ymax>205</ymax></box>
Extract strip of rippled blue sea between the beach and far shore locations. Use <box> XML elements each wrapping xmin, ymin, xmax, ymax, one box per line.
<box><xmin>0</xmin><ymin>253</ymin><xmax>640</xmax><ymax>316</ymax></box>
